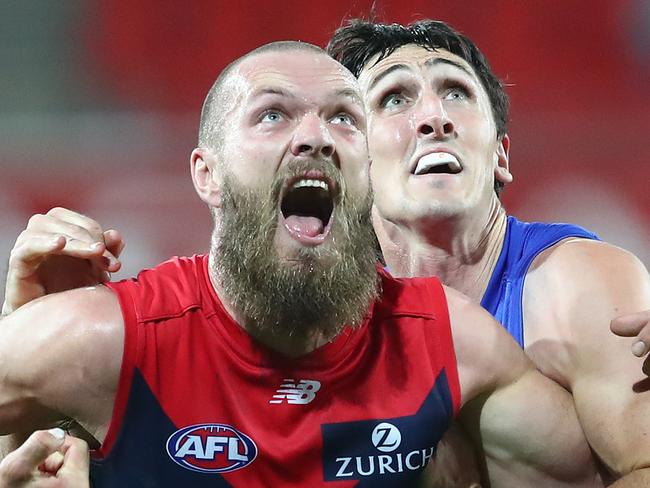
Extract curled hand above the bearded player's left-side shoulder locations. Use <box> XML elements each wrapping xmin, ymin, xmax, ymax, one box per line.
<box><xmin>2</xmin><ymin>208</ymin><xmax>124</xmax><ymax>315</ymax></box>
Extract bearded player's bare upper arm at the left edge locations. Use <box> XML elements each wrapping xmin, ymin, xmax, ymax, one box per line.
<box><xmin>0</xmin><ymin>286</ymin><xmax>124</xmax><ymax>440</ymax></box>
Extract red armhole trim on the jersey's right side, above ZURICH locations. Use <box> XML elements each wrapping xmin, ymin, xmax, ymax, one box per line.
<box><xmin>427</xmin><ymin>278</ymin><xmax>462</xmax><ymax>418</ymax></box>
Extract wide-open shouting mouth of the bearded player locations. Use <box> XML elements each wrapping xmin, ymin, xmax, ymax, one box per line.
<box><xmin>280</xmin><ymin>177</ymin><xmax>334</xmax><ymax>243</ymax></box>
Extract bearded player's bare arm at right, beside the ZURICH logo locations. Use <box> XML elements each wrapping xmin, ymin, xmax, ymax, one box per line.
<box><xmin>447</xmin><ymin>289</ymin><xmax>599</xmax><ymax>487</ymax></box>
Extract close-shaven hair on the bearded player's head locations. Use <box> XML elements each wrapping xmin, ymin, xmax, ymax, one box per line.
<box><xmin>199</xmin><ymin>41</ymin><xmax>329</xmax><ymax>150</ymax></box>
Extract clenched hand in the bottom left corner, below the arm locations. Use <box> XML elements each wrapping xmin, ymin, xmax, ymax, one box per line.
<box><xmin>0</xmin><ymin>429</ymin><xmax>90</xmax><ymax>488</ymax></box>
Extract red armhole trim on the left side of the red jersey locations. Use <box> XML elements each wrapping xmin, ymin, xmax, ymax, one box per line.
<box><xmin>91</xmin><ymin>281</ymin><xmax>140</xmax><ymax>459</ymax></box>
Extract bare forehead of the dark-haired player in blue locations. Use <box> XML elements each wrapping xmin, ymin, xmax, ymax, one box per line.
<box><xmin>359</xmin><ymin>44</ymin><xmax>476</xmax><ymax>91</ymax></box>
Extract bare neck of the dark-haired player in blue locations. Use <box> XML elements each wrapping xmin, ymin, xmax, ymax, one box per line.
<box><xmin>375</xmin><ymin>197</ymin><xmax>507</xmax><ymax>302</ymax></box>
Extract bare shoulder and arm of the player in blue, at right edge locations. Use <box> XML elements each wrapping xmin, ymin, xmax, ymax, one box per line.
<box><xmin>525</xmin><ymin>240</ymin><xmax>650</xmax><ymax>480</ymax></box>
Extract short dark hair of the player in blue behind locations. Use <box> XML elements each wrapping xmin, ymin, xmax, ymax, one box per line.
<box><xmin>327</xmin><ymin>19</ymin><xmax>508</xmax><ymax>194</ymax></box>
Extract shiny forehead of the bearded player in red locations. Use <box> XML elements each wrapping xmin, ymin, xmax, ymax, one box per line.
<box><xmin>232</xmin><ymin>50</ymin><xmax>361</xmax><ymax>102</ymax></box>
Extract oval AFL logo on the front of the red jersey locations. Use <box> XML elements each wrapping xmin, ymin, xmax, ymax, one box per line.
<box><xmin>167</xmin><ymin>424</ymin><xmax>257</xmax><ymax>473</ymax></box>
